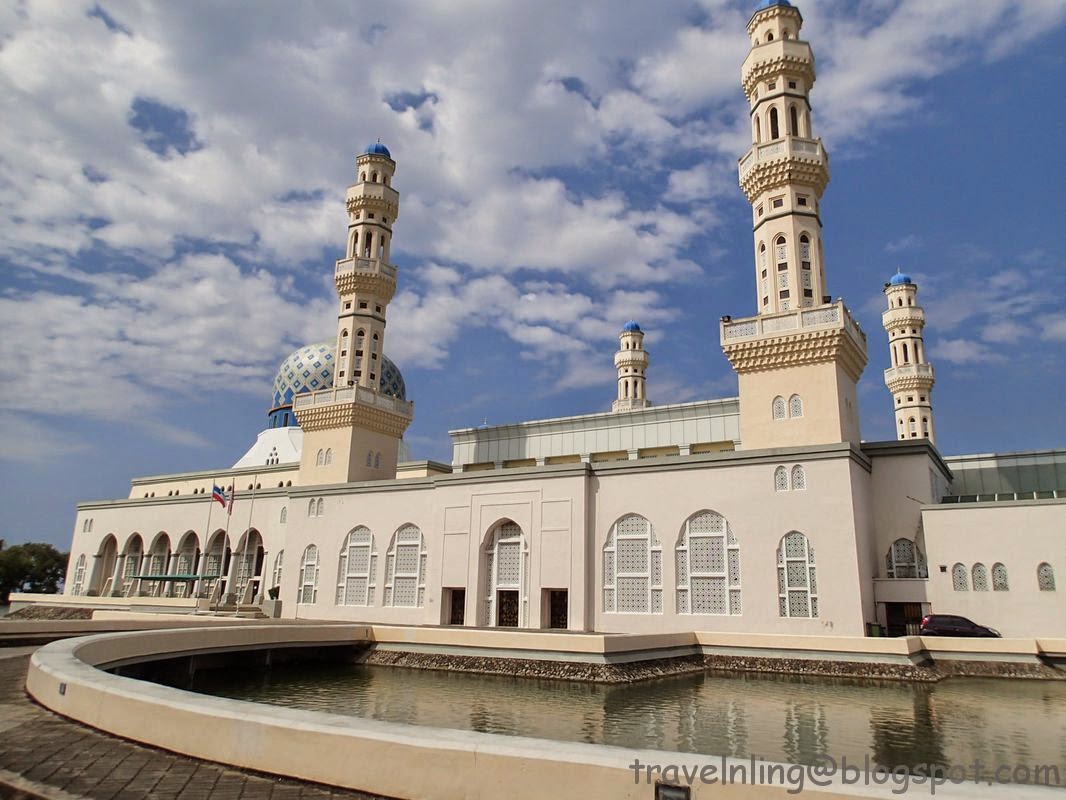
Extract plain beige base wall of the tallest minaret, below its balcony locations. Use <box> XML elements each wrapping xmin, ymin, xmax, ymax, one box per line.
<box><xmin>739</xmin><ymin>363</ymin><xmax>859</xmax><ymax>450</ymax></box>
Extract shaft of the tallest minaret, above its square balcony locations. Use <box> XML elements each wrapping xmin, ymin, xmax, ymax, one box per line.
<box><xmin>740</xmin><ymin>0</ymin><xmax>829</xmax><ymax>314</ymax></box>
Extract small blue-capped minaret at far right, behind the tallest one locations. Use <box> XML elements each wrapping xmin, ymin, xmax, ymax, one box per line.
<box><xmin>881</xmin><ymin>272</ymin><xmax>936</xmax><ymax>444</ymax></box>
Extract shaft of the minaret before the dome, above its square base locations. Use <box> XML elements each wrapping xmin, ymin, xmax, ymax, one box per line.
<box><xmin>335</xmin><ymin>142</ymin><xmax>400</xmax><ymax>389</ymax></box>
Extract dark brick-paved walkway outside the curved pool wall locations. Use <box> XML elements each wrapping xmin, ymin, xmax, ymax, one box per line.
<box><xmin>0</xmin><ymin>647</ymin><xmax>390</xmax><ymax>800</ymax></box>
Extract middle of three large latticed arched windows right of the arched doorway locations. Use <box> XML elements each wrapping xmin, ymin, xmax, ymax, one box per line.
<box><xmin>674</xmin><ymin>511</ymin><xmax>741</xmax><ymax>615</ymax></box>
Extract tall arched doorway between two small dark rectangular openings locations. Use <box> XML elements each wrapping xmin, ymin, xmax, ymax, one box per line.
<box><xmin>485</xmin><ymin>519</ymin><xmax>529</xmax><ymax>628</ymax></box>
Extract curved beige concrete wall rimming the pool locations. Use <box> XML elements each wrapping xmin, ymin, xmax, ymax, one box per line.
<box><xmin>27</xmin><ymin>624</ymin><xmax>1046</xmax><ymax>800</ymax></box>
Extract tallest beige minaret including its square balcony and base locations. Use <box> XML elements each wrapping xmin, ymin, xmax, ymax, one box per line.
<box><xmin>720</xmin><ymin>0</ymin><xmax>867</xmax><ymax>449</ymax></box>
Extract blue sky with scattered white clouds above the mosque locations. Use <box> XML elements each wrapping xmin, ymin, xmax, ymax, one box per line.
<box><xmin>0</xmin><ymin>0</ymin><xmax>1066</xmax><ymax>546</ymax></box>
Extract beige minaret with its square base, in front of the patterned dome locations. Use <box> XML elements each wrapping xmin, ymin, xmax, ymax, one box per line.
<box><xmin>293</xmin><ymin>142</ymin><xmax>414</xmax><ymax>485</ymax></box>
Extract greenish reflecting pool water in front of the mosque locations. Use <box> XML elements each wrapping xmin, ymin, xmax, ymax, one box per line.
<box><xmin>193</xmin><ymin>663</ymin><xmax>1066</xmax><ymax>779</ymax></box>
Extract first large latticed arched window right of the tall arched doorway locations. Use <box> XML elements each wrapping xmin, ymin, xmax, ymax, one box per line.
<box><xmin>603</xmin><ymin>514</ymin><xmax>663</xmax><ymax>613</ymax></box>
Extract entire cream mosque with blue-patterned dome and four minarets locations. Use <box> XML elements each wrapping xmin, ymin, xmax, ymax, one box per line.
<box><xmin>65</xmin><ymin>0</ymin><xmax>1066</xmax><ymax>636</ymax></box>
